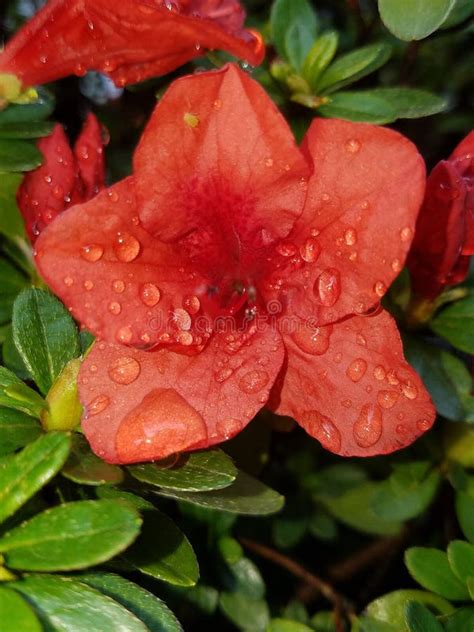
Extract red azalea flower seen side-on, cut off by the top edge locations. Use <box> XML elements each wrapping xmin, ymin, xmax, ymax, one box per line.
<box><xmin>0</xmin><ymin>0</ymin><xmax>265</xmax><ymax>86</ymax></box>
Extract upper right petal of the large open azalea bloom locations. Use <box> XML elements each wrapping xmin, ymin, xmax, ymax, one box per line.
<box><xmin>262</xmin><ymin>119</ymin><xmax>425</xmax><ymax>324</ymax></box>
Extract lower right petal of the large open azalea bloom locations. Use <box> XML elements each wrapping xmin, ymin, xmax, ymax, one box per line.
<box><xmin>270</xmin><ymin>312</ymin><xmax>435</xmax><ymax>456</ymax></box>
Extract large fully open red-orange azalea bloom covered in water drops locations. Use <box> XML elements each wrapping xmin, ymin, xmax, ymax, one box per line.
<box><xmin>37</xmin><ymin>65</ymin><xmax>434</xmax><ymax>463</ymax></box>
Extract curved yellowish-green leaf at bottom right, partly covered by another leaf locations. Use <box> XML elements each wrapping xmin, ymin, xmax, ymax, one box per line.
<box><xmin>367</xmin><ymin>590</ymin><xmax>454</xmax><ymax>632</ymax></box>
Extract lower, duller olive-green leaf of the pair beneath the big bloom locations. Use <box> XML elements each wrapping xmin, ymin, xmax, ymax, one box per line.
<box><xmin>155</xmin><ymin>472</ymin><xmax>284</xmax><ymax>516</ymax></box>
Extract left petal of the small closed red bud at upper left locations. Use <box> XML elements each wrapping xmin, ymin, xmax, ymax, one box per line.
<box><xmin>17</xmin><ymin>124</ymin><xmax>77</xmax><ymax>242</ymax></box>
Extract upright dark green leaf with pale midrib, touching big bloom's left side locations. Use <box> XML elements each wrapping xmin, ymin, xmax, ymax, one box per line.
<box><xmin>12</xmin><ymin>288</ymin><xmax>81</xmax><ymax>394</ymax></box>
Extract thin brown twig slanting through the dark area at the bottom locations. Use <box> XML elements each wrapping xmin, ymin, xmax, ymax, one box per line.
<box><xmin>240</xmin><ymin>538</ymin><xmax>354</xmax><ymax>632</ymax></box>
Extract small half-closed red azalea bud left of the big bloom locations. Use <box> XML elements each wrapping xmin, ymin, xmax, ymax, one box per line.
<box><xmin>17</xmin><ymin>114</ymin><xmax>105</xmax><ymax>243</ymax></box>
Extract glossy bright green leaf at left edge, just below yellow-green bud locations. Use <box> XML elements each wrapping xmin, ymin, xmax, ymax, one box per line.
<box><xmin>0</xmin><ymin>432</ymin><xmax>70</xmax><ymax>522</ymax></box>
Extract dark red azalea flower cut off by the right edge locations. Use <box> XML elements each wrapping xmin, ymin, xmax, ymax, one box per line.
<box><xmin>407</xmin><ymin>131</ymin><xmax>474</xmax><ymax>300</ymax></box>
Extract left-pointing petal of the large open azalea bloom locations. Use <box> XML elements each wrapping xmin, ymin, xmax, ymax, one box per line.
<box><xmin>36</xmin><ymin>178</ymin><xmax>215</xmax><ymax>348</ymax></box>
